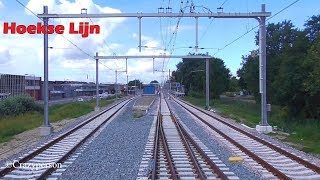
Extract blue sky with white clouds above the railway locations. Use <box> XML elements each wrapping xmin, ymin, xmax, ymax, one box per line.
<box><xmin>0</xmin><ymin>0</ymin><xmax>320</xmax><ymax>83</ymax></box>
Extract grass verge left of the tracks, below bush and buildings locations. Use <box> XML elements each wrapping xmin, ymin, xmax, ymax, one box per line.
<box><xmin>0</xmin><ymin>99</ymin><xmax>114</xmax><ymax>143</ymax></box>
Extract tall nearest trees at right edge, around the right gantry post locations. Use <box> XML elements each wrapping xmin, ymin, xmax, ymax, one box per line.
<box><xmin>237</xmin><ymin>15</ymin><xmax>320</xmax><ymax>120</ymax></box>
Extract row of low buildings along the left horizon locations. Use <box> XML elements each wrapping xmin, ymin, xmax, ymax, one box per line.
<box><xmin>0</xmin><ymin>74</ymin><xmax>124</xmax><ymax>100</ymax></box>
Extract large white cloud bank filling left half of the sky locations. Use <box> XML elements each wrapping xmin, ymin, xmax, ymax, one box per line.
<box><xmin>0</xmin><ymin>0</ymin><xmax>168</xmax><ymax>83</ymax></box>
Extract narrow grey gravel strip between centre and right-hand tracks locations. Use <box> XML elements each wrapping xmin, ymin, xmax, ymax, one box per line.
<box><xmin>168</xmin><ymin>100</ymin><xmax>261</xmax><ymax>180</ymax></box>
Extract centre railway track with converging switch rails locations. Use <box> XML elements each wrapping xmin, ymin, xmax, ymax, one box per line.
<box><xmin>148</xmin><ymin>95</ymin><xmax>239</xmax><ymax>179</ymax></box>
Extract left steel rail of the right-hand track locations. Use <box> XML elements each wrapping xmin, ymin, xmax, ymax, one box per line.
<box><xmin>174</xmin><ymin>99</ymin><xmax>290</xmax><ymax>180</ymax></box>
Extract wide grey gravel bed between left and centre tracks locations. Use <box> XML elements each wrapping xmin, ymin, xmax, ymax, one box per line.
<box><xmin>60</xmin><ymin>98</ymin><xmax>157</xmax><ymax>179</ymax></box>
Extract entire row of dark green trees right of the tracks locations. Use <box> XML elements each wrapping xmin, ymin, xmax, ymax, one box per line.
<box><xmin>172</xmin><ymin>15</ymin><xmax>320</xmax><ymax>120</ymax></box>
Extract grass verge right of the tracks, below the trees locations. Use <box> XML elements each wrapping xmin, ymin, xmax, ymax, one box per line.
<box><xmin>185</xmin><ymin>97</ymin><xmax>320</xmax><ymax>154</ymax></box>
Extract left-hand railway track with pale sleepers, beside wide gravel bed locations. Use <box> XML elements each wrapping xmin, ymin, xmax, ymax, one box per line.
<box><xmin>0</xmin><ymin>99</ymin><xmax>132</xmax><ymax>179</ymax></box>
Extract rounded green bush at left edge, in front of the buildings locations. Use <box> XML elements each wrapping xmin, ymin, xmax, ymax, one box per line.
<box><xmin>0</xmin><ymin>95</ymin><xmax>43</xmax><ymax>116</ymax></box>
